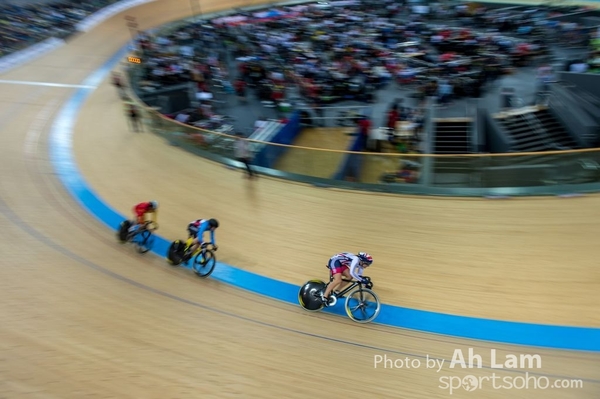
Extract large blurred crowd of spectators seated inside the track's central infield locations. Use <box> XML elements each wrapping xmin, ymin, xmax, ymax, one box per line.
<box><xmin>131</xmin><ymin>1</ymin><xmax>568</xmax><ymax>115</ymax></box>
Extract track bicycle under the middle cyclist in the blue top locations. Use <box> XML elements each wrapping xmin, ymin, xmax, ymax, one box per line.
<box><xmin>167</xmin><ymin>238</ymin><xmax>217</xmax><ymax>278</ymax></box>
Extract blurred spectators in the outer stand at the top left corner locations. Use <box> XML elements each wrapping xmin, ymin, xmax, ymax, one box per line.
<box><xmin>0</xmin><ymin>0</ymin><xmax>119</xmax><ymax>57</ymax></box>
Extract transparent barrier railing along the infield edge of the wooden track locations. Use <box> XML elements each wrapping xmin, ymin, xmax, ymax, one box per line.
<box><xmin>126</xmin><ymin>85</ymin><xmax>600</xmax><ymax>196</ymax></box>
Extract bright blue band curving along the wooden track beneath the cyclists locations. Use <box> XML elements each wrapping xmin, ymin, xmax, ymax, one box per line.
<box><xmin>50</xmin><ymin>42</ymin><xmax>600</xmax><ymax>352</ymax></box>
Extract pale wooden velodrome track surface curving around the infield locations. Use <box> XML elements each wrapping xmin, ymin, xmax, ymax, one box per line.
<box><xmin>0</xmin><ymin>0</ymin><xmax>600</xmax><ymax>399</ymax></box>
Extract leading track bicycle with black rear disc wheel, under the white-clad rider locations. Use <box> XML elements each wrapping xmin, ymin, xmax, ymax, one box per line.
<box><xmin>298</xmin><ymin>266</ymin><xmax>381</xmax><ymax>323</ymax></box>
